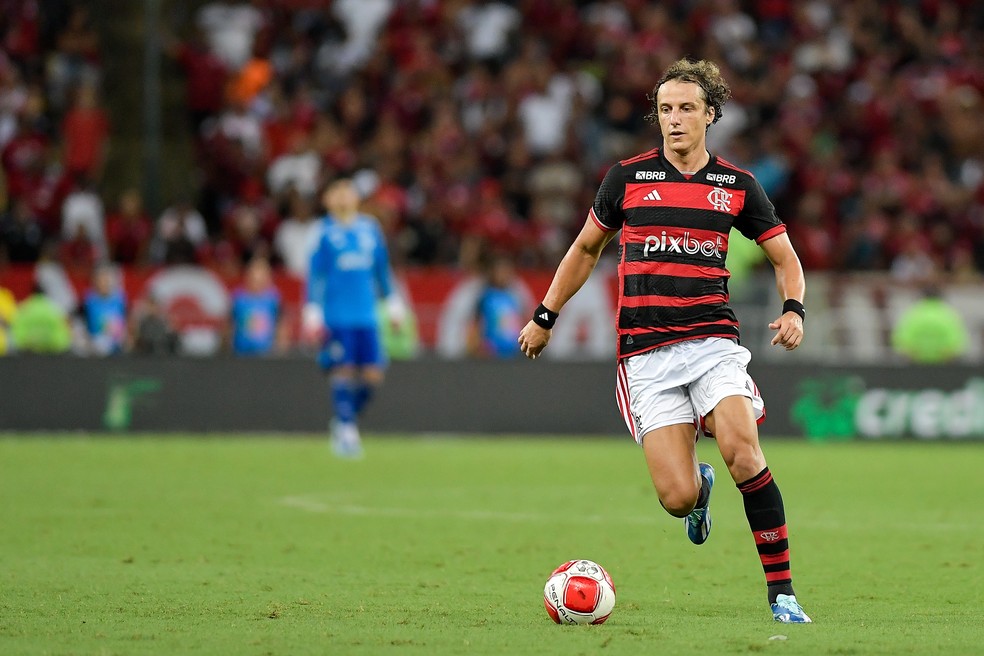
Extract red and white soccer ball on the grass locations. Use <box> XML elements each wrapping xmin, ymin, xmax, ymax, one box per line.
<box><xmin>543</xmin><ymin>560</ymin><xmax>615</xmax><ymax>624</ymax></box>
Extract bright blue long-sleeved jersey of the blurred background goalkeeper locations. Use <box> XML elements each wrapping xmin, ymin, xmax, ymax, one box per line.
<box><xmin>307</xmin><ymin>214</ymin><xmax>393</xmax><ymax>328</ymax></box>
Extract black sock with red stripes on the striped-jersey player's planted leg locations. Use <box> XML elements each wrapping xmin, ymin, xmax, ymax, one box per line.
<box><xmin>738</xmin><ymin>467</ymin><xmax>793</xmax><ymax>604</ymax></box>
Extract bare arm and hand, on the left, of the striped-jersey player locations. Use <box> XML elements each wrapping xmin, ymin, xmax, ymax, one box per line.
<box><xmin>519</xmin><ymin>216</ymin><xmax>616</xmax><ymax>360</ymax></box>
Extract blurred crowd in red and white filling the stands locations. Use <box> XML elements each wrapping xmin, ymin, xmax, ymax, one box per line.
<box><xmin>0</xmin><ymin>0</ymin><xmax>984</xmax><ymax>354</ymax></box>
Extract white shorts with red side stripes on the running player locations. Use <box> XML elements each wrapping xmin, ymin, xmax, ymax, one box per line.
<box><xmin>615</xmin><ymin>337</ymin><xmax>765</xmax><ymax>444</ymax></box>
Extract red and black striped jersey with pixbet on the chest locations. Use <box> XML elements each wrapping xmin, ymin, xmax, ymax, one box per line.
<box><xmin>590</xmin><ymin>149</ymin><xmax>786</xmax><ymax>358</ymax></box>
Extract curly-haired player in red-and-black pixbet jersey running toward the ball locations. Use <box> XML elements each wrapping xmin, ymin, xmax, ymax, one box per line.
<box><xmin>519</xmin><ymin>60</ymin><xmax>811</xmax><ymax>622</ymax></box>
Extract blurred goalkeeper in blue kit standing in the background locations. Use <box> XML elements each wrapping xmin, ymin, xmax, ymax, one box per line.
<box><xmin>302</xmin><ymin>178</ymin><xmax>406</xmax><ymax>458</ymax></box>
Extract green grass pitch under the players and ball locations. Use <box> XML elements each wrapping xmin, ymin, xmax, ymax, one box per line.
<box><xmin>0</xmin><ymin>435</ymin><xmax>984</xmax><ymax>656</ymax></box>
